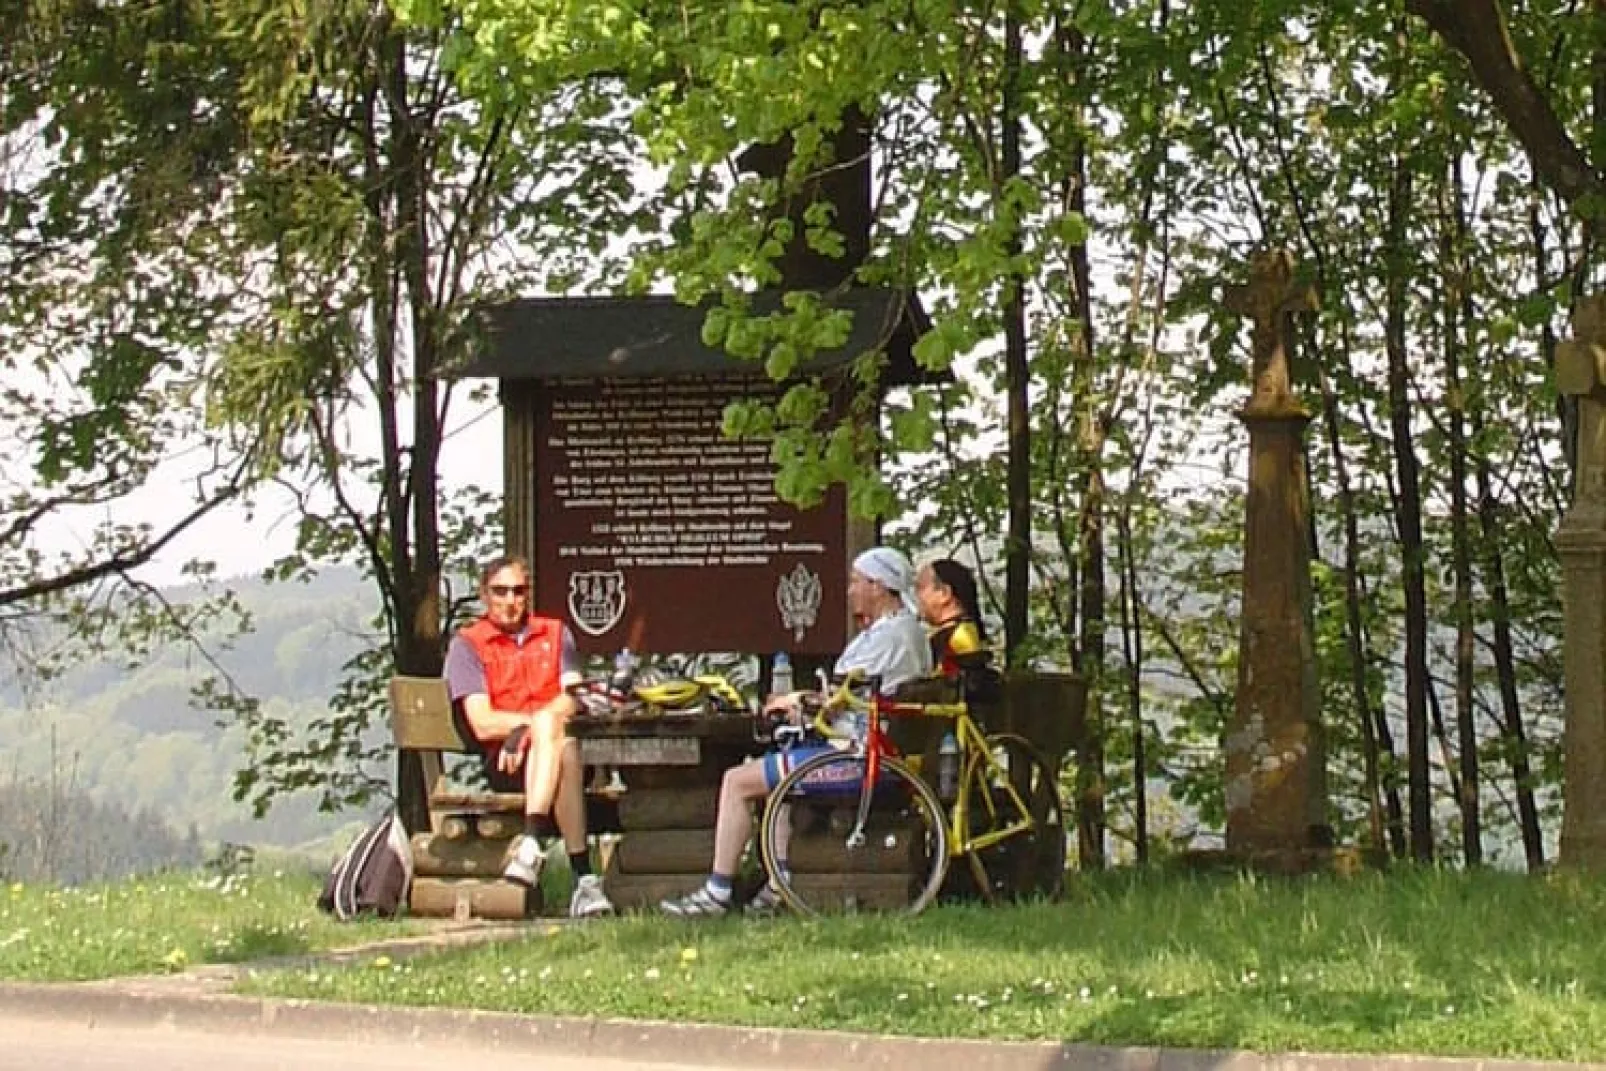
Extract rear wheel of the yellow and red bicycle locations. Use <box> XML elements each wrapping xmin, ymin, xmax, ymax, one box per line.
<box><xmin>960</xmin><ymin>732</ymin><xmax>1066</xmax><ymax>901</ymax></box>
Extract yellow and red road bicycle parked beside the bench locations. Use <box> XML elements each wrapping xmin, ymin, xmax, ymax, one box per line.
<box><xmin>760</xmin><ymin>673</ymin><xmax>1065</xmax><ymax>915</ymax></box>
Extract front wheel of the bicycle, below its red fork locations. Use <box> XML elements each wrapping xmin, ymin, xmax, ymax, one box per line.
<box><xmin>758</xmin><ymin>751</ymin><xmax>948</xmax><ymax>915</ymax></box>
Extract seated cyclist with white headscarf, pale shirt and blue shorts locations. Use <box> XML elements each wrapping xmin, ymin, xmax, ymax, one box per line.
<box><xmin>658</xmin><ymin>546</ymin><xmax>931</xmax><ymax>918</ymax></box>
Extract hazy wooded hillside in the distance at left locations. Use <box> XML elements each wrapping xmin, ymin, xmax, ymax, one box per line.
<box><xmin>0</xmin><ymin>570</ymin><xmax>374</xmax><ymax>880</ymax></box>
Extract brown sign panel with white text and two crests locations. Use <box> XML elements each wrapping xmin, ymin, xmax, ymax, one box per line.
<box><xmin>535</xmin><ymin>376</ymin><xmax>848</xmax><ymax>655</ymax></box>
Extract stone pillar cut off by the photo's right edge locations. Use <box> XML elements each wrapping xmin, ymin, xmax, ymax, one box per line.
<box><xmin>1556</xmin><ymin>294</ymin><xmax>1606</xmax><ymax>870</ymax></box>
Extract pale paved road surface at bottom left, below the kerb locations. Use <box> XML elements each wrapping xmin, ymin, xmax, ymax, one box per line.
<box><xmin>0</xmin><ymin>1015</ymin><xmax>772</xmax><ymax>1071</ymax></box>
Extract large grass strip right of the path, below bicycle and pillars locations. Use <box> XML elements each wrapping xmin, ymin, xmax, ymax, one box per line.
<box><xmin>243</xmin><ymin>870</ymin><xmax>1606</xmax><ymax>1060</ymax></box>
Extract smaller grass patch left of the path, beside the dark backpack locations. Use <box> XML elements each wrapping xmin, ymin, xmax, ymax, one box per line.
<box><xmin>0</xmin><ymin>870</ymin><xmax>416</xmax><ymax>981</ymax></box>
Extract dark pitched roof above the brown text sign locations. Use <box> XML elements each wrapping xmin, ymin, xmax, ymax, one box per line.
<box><xmin>446</xmin><ymin>289</ymin><xmax>949</xmax><ymax>385</ymax></box>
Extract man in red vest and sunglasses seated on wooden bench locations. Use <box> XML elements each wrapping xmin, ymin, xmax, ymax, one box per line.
<box><xmin>445</xmin><ymin>557</ymin><xmax>613</xmax><ymax>918</ymax></box>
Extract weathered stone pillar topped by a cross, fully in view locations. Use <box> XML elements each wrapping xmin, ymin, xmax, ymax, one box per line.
<box><xmin>1225</xmin><ymin>250</ymin><xmax>1330</xmax><ymax>856</ymax></box>
